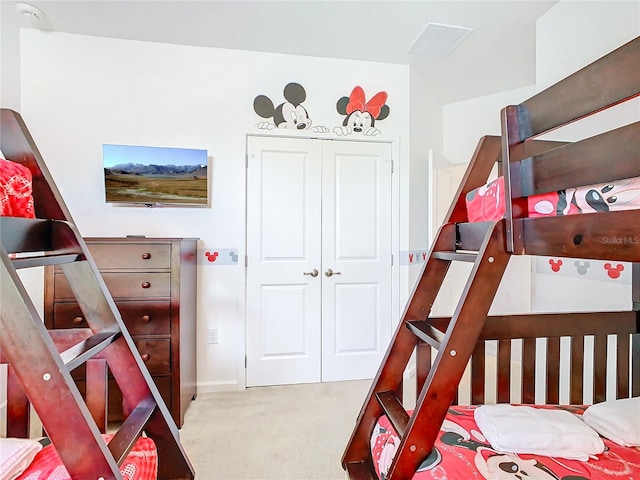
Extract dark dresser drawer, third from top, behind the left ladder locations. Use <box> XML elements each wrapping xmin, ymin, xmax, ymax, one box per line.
<box><xmin>53</xmin><ymin>301</ymin><xmax>171</xmax><ymax>335</ymax></box>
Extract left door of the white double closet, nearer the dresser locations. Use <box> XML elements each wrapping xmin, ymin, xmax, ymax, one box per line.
<box><xmin>247</xmin><ymin>137</ymin><xmax>321</xmax><ymax>386</ymax></box>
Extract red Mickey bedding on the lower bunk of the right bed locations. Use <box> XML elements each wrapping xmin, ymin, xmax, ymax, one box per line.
<box><xmin>371</xmin><ymin>406</ymin><xmax>640</xmax><ymax>480</ymax></box>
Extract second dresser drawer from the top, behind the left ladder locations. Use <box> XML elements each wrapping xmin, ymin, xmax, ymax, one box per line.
<box><xmin>53</xmin><ymin>272</ymin><xmax>171</xmax><ymax>300</ymax></box>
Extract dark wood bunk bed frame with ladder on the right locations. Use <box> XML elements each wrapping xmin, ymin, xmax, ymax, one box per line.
<box><xmin>342</xmin><ymin>37</ymin><xmax>640</xmax><ymax>480</ymax></box>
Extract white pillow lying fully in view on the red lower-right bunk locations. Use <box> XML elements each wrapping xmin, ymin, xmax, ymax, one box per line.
<box><xmin>474</xmin><ymin>404</ymin><xmax>604</xmax><ymax>461</ymax></box>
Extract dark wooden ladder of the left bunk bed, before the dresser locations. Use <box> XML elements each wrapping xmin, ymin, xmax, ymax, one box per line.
<box><xmin>0</xmin><ymin>109</ymin><xmax>195</xmax><ymax>479</ymax></box>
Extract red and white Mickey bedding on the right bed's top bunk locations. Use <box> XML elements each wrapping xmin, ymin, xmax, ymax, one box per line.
<box><xmin>465</xmin><ymin>177</ymin><xmax>640</xmax><ymax>222</ymax></box>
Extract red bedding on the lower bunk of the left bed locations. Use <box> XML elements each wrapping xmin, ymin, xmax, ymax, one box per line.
<box><xmin>16</xmin><ymin>435</ymin><xmax>158</xmax><ymax>480</ymax></box>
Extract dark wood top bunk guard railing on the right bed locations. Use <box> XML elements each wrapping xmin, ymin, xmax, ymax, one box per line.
<box><xmin>501</xmin><ymin>37</ymin><xmax>640</xmax><ymax>261</ymax></box>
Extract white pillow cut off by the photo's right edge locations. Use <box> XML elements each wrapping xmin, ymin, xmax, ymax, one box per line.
<box><xmin>582</xmin><ymin>397</ymin><xmax>640</xmax><ymax>447</ymax></box>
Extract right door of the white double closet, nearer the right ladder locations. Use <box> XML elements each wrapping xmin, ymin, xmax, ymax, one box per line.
<box><xmin>322</xmin><ymin>141</ymin><xmax>392</xmax><ymax>381</ymax></box>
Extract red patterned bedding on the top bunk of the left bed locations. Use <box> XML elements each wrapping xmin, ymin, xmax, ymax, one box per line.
<box><xmin>0</xmin><ymin>158</ymin><xmax>35</xmax><ymax>218</ymax></box>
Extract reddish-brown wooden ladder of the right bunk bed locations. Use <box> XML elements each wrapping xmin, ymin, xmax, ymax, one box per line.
<box><xmin>342</xmin><ymin>137</ymin><xmax>510</xmax><ymax>479</ymax></box>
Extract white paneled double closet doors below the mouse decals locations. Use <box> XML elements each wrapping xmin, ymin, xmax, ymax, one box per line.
<box><xmin>246</xmin><ymin>136</ymin><xmax>392</xmax><ymax>386</ymax></box>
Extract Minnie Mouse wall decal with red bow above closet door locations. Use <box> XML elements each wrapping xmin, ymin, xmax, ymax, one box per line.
<box><xmin>333</xmin><ymin>86</ymin><xmax>390</xmax><ymax>136</ymax></box>
